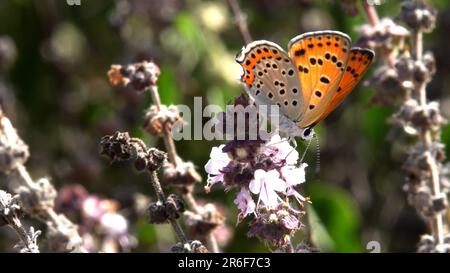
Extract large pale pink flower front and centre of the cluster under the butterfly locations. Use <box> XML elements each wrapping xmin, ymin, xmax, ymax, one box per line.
<box><xmin>250</xmin><ymin>169</ymin><xmax>286</xmax><ymax>209</ymax></box>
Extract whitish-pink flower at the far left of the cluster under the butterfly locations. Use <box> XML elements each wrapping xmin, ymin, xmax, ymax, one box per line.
<box><xmin>205</xmin><ymin>144</ymin><xmax>231</xmax><ymax>187</ymax></box>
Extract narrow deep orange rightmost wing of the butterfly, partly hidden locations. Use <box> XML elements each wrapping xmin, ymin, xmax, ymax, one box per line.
<box><xmin>314</xmin><ymin>47</ymin><xmax>375</xmax><ymax>124</ymax></box>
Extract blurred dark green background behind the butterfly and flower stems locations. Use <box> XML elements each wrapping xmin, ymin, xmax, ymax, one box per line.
<box><xmin>0</xmin><ymin>0</ymin><xmax>450</xmax><ymax>252</ymax></box>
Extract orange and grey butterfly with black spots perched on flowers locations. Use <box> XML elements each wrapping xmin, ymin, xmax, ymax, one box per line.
<box><xmin>236</xmin><ymin>30</ymin><xmax>375</xmax><ymax>140</ymax></box>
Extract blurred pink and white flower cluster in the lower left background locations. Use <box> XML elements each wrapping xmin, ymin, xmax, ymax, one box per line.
<box><xmin>56</xmin><ymin>184</ymin><xmax>135</xmax><ymax>252</ymax></box>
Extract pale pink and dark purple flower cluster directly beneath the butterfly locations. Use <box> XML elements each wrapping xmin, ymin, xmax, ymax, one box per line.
<box><xmin>205</xmin><ymin>96</ymin><xmax>308</xmax><ymax>248</ymax></box>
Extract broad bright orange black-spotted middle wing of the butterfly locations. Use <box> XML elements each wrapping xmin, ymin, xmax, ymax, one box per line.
<box><xmin>288</xmin><ymin>31</ymin><xmax>351</xmax><ymax>128</ymax></box>
